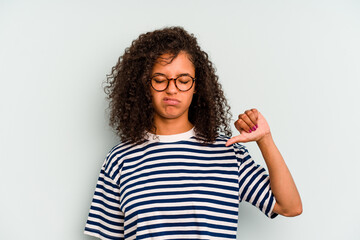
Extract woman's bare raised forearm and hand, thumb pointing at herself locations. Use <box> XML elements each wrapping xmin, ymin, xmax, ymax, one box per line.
<box><xmin>226</xmin><ymin>109</ymin><xmax>302</xmax><ymax>217</ymax></box>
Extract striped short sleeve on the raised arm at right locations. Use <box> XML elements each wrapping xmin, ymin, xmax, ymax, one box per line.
<box><xmin>234</xmin><ymin>143</ymin><xmax>278</xmax><ymax>218</ymax></box>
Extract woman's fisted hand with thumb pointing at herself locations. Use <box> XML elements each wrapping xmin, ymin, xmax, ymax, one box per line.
<box><xmin>226</xmin><ymin>108</ymin><xmax>270</xmax><ymax>146</ymax></box>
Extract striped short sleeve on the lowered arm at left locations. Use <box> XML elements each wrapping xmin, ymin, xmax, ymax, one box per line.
<box><xmin>84</xmin><ymin>158</ymin><xmax>124</xmax><ymax>240</ymax></box>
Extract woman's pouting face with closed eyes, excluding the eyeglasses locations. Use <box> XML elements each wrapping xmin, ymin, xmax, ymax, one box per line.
<box><xmin>150</xmin><ymin>52</ymin><xmax>195</xmax><ymax>122</ymax></box>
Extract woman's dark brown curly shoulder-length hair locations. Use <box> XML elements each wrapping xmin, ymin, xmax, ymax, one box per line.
<box><xmin>104</xmin><ymin>27</ymin><xmax>232</xmax><ymax>144</ymax></box>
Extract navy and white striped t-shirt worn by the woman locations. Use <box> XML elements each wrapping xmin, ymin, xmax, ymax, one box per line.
<box><xmin>84</xmin><ymin>126</ymin><xmax>277</xmax><ymax>240</ymax></box>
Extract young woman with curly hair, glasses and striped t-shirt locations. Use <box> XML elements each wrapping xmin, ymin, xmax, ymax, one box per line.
<box><xmin>85</xmin><ymin>27</ymin><xmax>302</xmax><ymax>240</ymax></box>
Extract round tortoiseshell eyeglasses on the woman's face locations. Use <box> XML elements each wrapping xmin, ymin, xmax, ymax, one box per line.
<box><xmin>149</xmin><ymin>74</ymin><xmax>196</xmax><ymax>92</ymax></box>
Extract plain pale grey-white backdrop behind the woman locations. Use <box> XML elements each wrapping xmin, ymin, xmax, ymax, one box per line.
<box><xmin>0</xmin><ymin>0</ymin><xmax>360</xmax><ymax>240</ymax></box>
